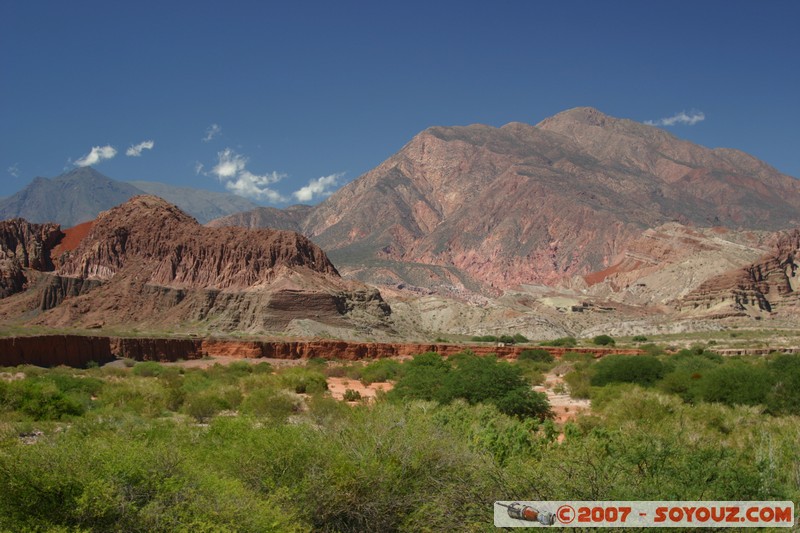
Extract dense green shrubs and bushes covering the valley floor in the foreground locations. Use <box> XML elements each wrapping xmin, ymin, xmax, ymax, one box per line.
<box><xmin>0</xmin><ymin>350</ymin><xmax>800</xmax><ymax>531</ymax></box>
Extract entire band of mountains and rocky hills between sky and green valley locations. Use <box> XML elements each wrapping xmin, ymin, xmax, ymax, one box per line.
<box><xmin>0</xmin><ymin>108</ymin><xmax>800</xmax><ymax>339</ymax></box>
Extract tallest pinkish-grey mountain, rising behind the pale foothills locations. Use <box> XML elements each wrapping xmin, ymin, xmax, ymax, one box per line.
<box><xmin>211</xmin><ymin>108</ymin><xmax>800</xmax><ymax>293</ymax></box>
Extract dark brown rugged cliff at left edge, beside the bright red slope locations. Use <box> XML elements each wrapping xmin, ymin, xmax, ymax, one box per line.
<box><xmin>0</xmin><ymin>218</ymin><xmax>63</xmax><ymax>298</ymax></box>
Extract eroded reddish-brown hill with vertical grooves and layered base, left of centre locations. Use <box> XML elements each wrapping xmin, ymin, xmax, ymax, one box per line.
<box><xmin>0</xmin><ymin>196</ymin><xmax>390</xmax><ymax>333</ymax></box>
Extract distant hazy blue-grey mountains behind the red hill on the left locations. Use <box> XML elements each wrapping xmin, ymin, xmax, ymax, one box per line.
<box><xmin>0</xmin><ymin>167</ymin><xmax>256</xmax><ymax>224</ymax></box>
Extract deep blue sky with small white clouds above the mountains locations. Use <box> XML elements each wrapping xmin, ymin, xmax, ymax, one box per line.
<box><xmin>0</xmin><ymin>0</ymin><xmax>800</xmax><ymax>205</ymax></box>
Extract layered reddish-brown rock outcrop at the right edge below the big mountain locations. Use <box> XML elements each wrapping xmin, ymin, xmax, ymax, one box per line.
<box><xmin>680</xmin><ymin>229</ymin><xmax>800</xmax><ymax>317</ymax></box>
